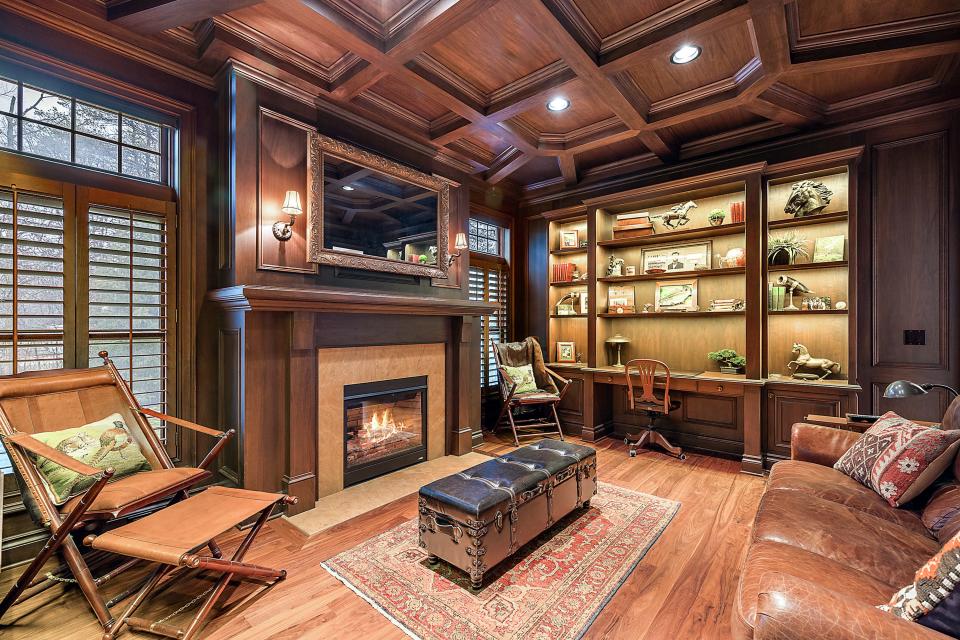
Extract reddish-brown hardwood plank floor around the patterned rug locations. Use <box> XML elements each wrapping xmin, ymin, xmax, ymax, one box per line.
<box><xmin>0</xmin><ymin>437</ymin><xmax>764</xmax><ymax>640</ymax></box>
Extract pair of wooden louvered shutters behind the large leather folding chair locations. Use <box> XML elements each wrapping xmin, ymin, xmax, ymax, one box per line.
<box><xmin>0</xmin><ymin>180</ymin><xmax>175</xmax><ymax>469</ymax></box>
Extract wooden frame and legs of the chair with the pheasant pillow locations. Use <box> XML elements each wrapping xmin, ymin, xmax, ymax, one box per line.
<box><xmin>0</xmin><ymin>351</ymin><xmax>235</xmax><ymax>630</ymax></box>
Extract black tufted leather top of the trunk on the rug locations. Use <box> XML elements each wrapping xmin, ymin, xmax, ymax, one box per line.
<box><xmin>420</xmin><ymin>440</ymin><xmax>594</xmax><ymax>520</ymax></box>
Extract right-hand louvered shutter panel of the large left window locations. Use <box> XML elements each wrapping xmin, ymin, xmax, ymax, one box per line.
<box><xmin>87</xmin><ymin>206</ymin><xmax>171</xmax><ymax>442</ymax></box>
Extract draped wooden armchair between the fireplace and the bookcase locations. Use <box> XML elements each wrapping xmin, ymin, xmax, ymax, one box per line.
<box><xmin>493</xmin><ymin>337</ymin><xmax>570</xmax><ymax>447</ymax></box>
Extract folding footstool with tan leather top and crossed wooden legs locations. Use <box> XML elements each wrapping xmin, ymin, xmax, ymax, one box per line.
<box><xmin>83</xmin><ymin>487</ymin><xmax>297</xmax><ymax>640</ymax></box>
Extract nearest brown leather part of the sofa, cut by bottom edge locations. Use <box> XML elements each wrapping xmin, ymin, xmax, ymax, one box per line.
<box><xmin>753</xmin><ymin>573</ymin><xmax>950</xmax><ymax>640</ymax></box>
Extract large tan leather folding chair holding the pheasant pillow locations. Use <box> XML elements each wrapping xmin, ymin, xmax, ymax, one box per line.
<box><xmin>0</xmin><ymin>351</ymin><xmax>234</xmax><ymax>629</ymax></box>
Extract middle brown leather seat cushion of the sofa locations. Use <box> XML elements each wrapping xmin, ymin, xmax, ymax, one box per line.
<box><xmin>753</xmin><ymin>489</ymin><xmax>940</xmax><ymax>586</ymax></box>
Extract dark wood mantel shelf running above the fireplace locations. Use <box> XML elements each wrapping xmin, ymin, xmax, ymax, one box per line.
<box><xmin>207</xmin><ymin>285</ymin><xmax>497</xmax><ymax>316</ymax></box>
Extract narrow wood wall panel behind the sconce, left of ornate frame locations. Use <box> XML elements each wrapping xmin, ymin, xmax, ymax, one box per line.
<box><xmin>257</xmin><ymin>108</ymin><xmax>317</xmax><ymax>273</ymax></box>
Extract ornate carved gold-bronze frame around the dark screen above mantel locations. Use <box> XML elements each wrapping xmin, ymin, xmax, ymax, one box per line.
<box><xmin>307</xmin><ymin>132</ymin><xmax>451</xmax><ymax>278</ymax></box>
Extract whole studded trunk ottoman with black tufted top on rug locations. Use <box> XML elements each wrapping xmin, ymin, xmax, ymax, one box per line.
<box><xmin>419</xmin><ymin>440</ymin><xmax>597</xmax><ymax>589</ymax></box>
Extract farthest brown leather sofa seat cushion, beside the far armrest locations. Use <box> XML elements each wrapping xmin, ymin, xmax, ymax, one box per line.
<box><xmin>767</xmin><ymin>460</ymin><xmax>928</xmax><ymax>534</ymax></box>
